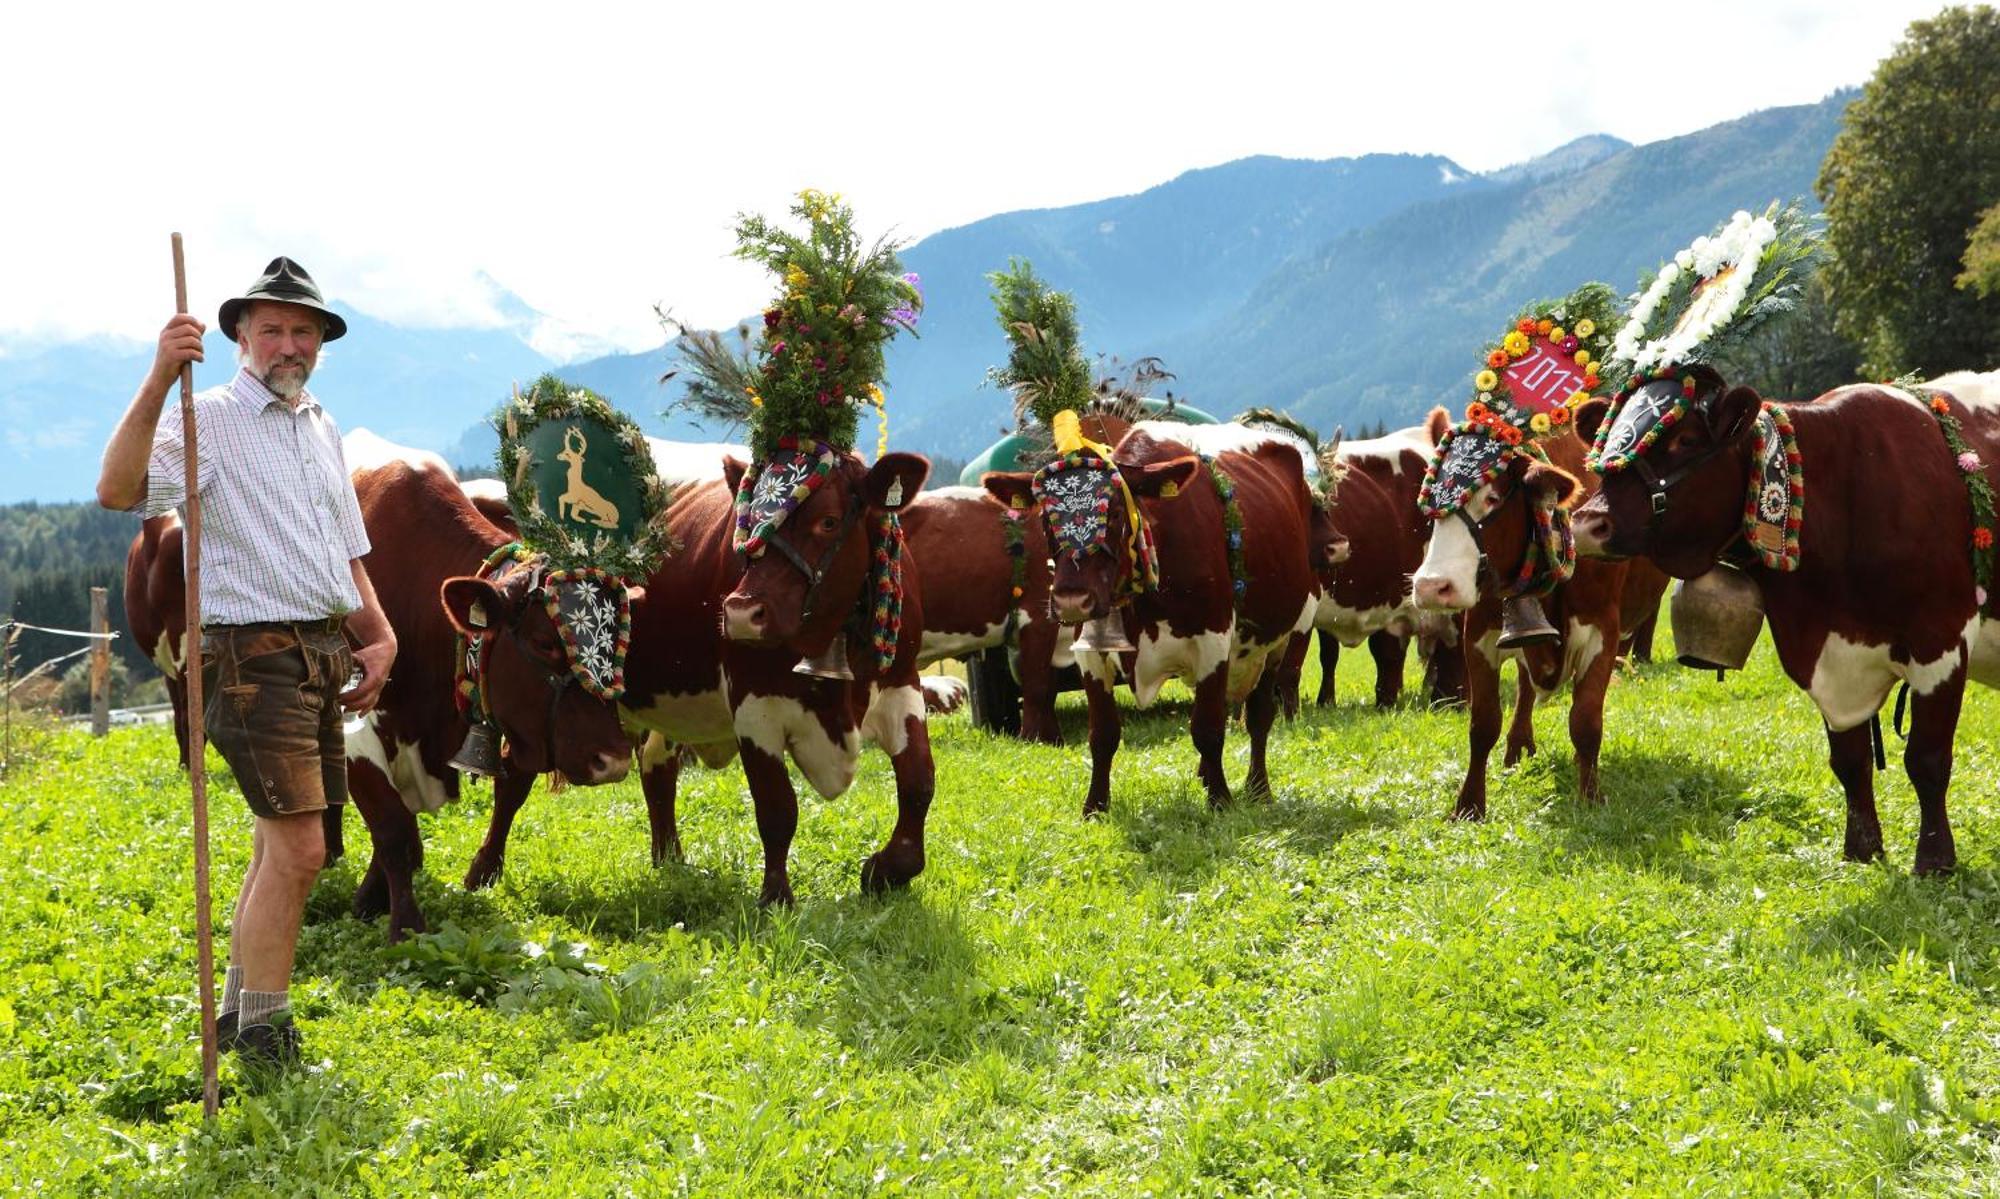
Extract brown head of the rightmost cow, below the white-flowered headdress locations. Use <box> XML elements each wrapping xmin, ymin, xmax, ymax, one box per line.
<box><xmin>1576</xmin><ymin>366</ymin><xmax>1764</xmax><ymax>578</ymax></box>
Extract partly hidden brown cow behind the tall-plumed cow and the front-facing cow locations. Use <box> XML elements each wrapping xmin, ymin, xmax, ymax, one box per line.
<box><xmin>902</xmin><ymin>488</ymin><xmax>1072</xmax><ymax>745</ymax></box>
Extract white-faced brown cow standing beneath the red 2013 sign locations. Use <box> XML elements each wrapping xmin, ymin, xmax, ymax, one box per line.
<box><xmin>1414</xmin><ymin>402</ymin><xmax>1626</xmax><ymax>819</ymax></box>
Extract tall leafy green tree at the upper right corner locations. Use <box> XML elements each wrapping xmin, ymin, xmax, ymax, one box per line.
<box><xmin>1816</xmin><ymin>4</ymin><xmax>2000</xmax><ymax>376</ymax></box>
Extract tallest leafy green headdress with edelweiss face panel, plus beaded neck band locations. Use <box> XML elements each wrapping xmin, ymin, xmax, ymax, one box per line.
<box><xmin>680</xmin><ymin>190</ymin><xmax>924</xmax><ymax>669</ymax></box>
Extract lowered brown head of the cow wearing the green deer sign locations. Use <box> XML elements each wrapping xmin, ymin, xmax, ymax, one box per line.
<box><xmin>440</xmin><ymin>566</ymin><xmax>638</xmax><ymax>783</ymax></box>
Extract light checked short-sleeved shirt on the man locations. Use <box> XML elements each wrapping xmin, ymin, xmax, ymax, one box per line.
<box><xmin>138</xmin><ymin>370</ymin><xmax>368</xmax><ymax>625</ymax></box>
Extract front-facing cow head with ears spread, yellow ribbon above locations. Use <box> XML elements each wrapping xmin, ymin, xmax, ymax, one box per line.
<box><xmin>980</xmin><ymin>445</ymin><xmax>1202</xmax><ymax>625</ymax></box>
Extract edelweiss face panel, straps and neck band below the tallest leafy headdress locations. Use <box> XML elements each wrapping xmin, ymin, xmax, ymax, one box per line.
<box><xmin>734</xmin><ymin>436</ymin><xmax>904</xmax><ymax>669</ymax></box>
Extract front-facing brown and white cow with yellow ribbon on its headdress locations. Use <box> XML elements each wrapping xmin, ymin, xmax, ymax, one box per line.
<box><xmin>982</xmin><ymin>422</ymin><xmax>1330</xmax><ymax>815</ymax></box>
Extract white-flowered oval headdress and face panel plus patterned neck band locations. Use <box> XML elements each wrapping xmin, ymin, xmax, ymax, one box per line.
<box><xmin>1584</xmin><ymin>202</ymin><xmax>1820</xmax><ymax>570</ymax></box>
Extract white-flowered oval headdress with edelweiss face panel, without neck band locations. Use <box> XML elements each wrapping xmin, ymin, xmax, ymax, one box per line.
<box><xmin>1586</xmin><ymin>202</ymin><xmax>1822</xmax><ymax>472</ymax></box>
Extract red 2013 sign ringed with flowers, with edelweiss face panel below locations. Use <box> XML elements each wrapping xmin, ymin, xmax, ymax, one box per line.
<box><xmin>1418</xmin><ymin>284</ymin><xmax>1622</xmax><ymax>520</ymax></box>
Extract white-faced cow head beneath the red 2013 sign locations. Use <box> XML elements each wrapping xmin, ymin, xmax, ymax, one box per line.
<box><xmin>1412</xmin><ymin>454</ymin><xmax>1582</xmax><ymax>611</ymax></box>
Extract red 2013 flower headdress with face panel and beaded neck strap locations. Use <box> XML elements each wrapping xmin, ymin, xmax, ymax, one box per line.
<box><xmin>1418</xmin><ymin>284</ymin><xmax>1616</xmax><ymax>598</ymax></box>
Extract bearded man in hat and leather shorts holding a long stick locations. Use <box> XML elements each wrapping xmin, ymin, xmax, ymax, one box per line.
<box><xmin>98</xmin><ymin>258</ymin><xmax>396</xmax><ymax>1065</ymax></box>
